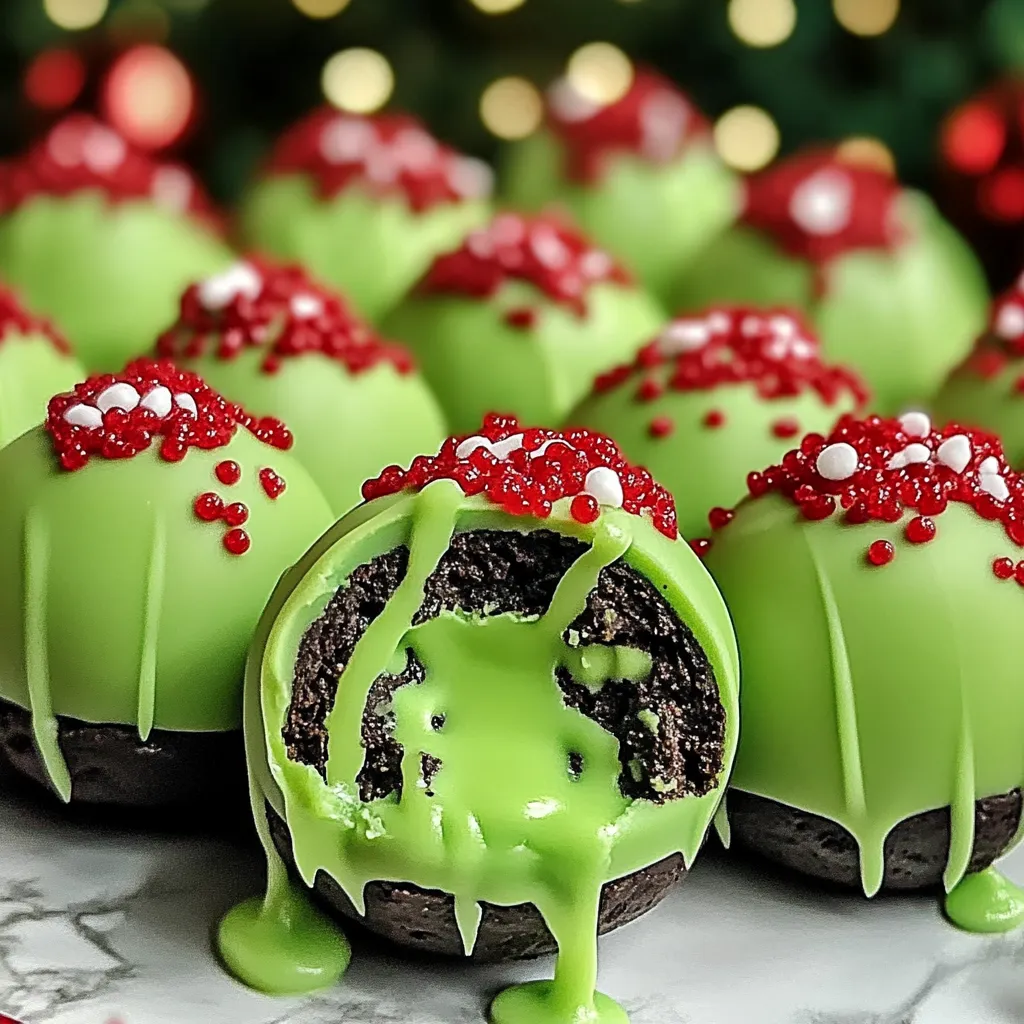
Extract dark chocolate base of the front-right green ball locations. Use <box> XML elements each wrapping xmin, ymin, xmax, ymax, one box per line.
<box><xmin>728</xmin><ymin>790</ymin><xmax>1022</xmax><ymax>891</ymax></box>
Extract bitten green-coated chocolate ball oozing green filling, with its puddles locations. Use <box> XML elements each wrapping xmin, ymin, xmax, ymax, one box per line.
<box><xmin>220</xmin><ymin>417</ymin><xmax>738</xmax><ymax>1022</ymax></box>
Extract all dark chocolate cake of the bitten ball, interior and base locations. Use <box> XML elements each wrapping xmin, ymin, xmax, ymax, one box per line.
<box><xmin>280</xmin><ymin>529</ymin><xmax>725</xmax><ymax>959</ymax></box>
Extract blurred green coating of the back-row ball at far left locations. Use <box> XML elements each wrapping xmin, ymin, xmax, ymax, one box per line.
<box><xmin>0</xmin><ymin>190</ymin><xmax>231</xmax><ymax>379</ymax></box>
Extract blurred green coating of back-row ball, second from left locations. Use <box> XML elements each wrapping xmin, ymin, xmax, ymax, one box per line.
<box><xmin>241</xmin><ymin>174</ymin><xmax>490</xmax><ymax>323</ymax></box>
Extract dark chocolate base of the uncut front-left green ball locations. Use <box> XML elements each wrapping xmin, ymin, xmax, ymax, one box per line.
<box><xmin>0</xmin><ymin>700</ymin><xmax>248</xmax><ymax>808</ymax></box>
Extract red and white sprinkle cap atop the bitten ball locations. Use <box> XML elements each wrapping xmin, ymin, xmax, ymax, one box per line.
<box><xmin>362</xmin><ymin>414</ymin><xmax>678</xmax><ymax>539</ymax></box>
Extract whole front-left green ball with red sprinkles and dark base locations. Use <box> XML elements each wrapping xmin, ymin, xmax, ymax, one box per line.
<box><xmin>0</xmin><ymin>360</ymin><xmax>332</xmax><ymax>807</ymax></box>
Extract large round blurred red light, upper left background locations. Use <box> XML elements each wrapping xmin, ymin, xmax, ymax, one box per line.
<box><xmin>102</xmin><ymin>44</ymin><xmax>196</xmax><ymax>150</ymax></box>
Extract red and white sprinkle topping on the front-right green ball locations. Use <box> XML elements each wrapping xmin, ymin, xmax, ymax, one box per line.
<box><xmin>733</xmin><ymin>413</ymin><xmax>1024</xmax><ymax>579</ymax></box>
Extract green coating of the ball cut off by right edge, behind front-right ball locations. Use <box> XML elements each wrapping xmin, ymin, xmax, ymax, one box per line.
<box><xmin>932</xmin><ymin>357</ymin><xmax>1024</xmax><ymax>470</ymax></box>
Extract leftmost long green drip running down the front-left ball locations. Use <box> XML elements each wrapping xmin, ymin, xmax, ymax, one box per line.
<box><xmin>24</xmin><ymin>509</ymin><xmax>71</xmax><ymax>803</ymax></box>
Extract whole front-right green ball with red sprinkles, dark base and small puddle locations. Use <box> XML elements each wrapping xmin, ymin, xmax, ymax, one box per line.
<box><xmin>705</xmin><ymin>413</ymin><xmax>1024</xmax><ymax>931</ymax></box>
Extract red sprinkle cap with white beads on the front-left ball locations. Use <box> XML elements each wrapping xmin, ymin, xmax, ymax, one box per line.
<box><xmin>45</xmin><ymin>359</ymin><xmax>293</xmax><ymax>470</ymax></box>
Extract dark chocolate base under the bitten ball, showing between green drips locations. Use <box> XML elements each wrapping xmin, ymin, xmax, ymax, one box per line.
<box><xmin>266</xmin><ymin>804</ymin><xmax>686</xmax><ymax>964</ymax></box>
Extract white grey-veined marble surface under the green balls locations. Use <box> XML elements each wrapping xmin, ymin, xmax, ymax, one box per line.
<box><xmin>0</xmin><ymin>774</ymin><xmax>1024</xmax><ymax>1024</ymax></box>
